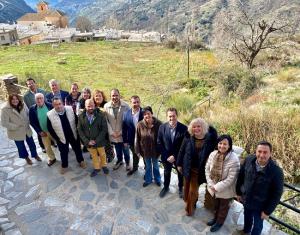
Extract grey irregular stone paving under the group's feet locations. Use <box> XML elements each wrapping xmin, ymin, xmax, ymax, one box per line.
<box><xmin>0</xmin><ymin>116</ymin><xmax>284</xmax><ymax>235</ymax></box>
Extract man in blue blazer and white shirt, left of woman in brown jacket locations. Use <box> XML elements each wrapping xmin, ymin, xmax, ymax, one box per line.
<box><xmin>122</xmin><ymin>95</ymin><xmax>144</xmax><ymax>176</ymax></box>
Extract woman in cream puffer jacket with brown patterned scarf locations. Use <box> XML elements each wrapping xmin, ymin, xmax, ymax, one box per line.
<box><xmin>205</xmin><ymin>135</ymin><xmax>240</xmax><ymax>232</ymax></box>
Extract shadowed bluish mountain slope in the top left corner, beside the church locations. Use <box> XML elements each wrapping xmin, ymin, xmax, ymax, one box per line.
<box><xmin>0</xmin><ymin>0</ymin><xmax>34</xmax><ymax>23</ymax></box>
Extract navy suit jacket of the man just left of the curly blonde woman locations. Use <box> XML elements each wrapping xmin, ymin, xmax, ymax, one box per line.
<box><xmin>157</xmin><ymin>122</ymin><xmax>187</xmax><ymax>164</ymax></box>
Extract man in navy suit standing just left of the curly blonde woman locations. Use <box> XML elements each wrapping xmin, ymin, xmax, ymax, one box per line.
<box><xmin>157</xmin><ymin>108</ymin><xmax>187</xmax><ymax>198</ymax></box>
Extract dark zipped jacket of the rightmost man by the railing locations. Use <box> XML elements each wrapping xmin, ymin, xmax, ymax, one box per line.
<box><xmin>236</xmin><ymin>155</ymin><xmax>283</xmax><ymax>215</ymax></box>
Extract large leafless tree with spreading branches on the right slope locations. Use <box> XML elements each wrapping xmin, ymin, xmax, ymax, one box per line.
<box><xmin>211</xmin><ymin>4</ymin><xmax>296</xmax><ymax>69</ymax></box>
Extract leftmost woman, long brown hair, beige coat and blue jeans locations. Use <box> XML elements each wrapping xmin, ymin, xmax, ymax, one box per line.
<box><xmin>1</xmin><ymin>94</ymin><xmax>42</xmax><ymax>165</ymax></box>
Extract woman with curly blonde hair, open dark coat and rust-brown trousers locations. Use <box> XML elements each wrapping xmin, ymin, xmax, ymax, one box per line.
<box><xmin>177</xmin><ymin>118</ymin><xmax>218</xmax><ymax>216</ymax></box>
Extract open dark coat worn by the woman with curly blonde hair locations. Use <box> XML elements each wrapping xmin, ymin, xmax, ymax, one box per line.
<box><xmin>177</xmin><ymin>126</ymin><xmax>218</xmax><ymax>184</ymax></box>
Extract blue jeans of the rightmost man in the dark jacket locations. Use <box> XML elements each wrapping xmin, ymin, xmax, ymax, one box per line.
<box><xmin>244</xmin><ymin>208</ymin><xmax>264</xmax><ymax>235</ymax></box>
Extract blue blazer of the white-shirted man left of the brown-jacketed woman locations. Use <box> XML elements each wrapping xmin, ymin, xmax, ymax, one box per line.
<box><xmin>122</xmin><ymin>109</ymin><xmax>144</xmax><ymax>146</ymax></box>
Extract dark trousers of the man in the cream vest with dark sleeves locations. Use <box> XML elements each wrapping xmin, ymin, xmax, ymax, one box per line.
<box><xmin>57</xmin><ymin>138</ymin><xmax>84</xmax><ymax>168</ymax></box>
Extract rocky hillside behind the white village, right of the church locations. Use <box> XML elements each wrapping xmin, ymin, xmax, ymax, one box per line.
<box><xmin>55</xmin><ymin>0</ymin><xmax>300</xmax><ymax>41</ymax></box>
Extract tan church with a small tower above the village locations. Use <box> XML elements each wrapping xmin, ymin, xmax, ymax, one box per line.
<box><xmin>17</xmin><ymin>1</ymin><xmax>68</xmax><ymax>30</ymax></box>
